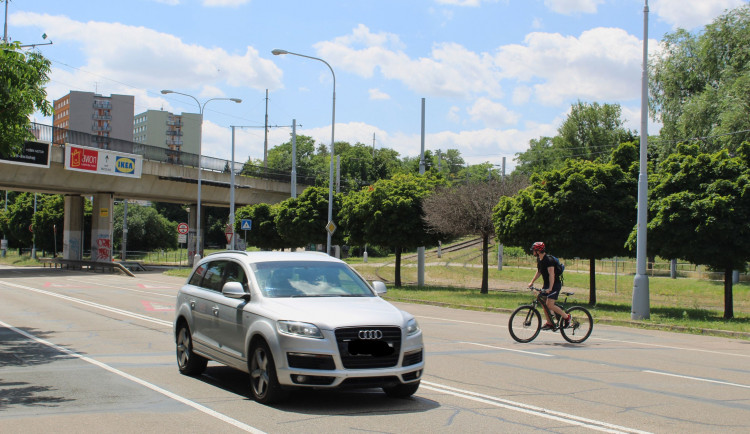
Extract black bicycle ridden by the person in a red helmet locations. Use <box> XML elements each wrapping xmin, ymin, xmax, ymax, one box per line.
<box><xmin>508</xmin><ymin>287</ymin><xmax>594</xmax><ymax>344</ymax></box>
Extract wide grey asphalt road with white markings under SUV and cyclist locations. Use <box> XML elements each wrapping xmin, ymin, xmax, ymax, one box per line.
<box><xmin>0</xmin><ymin>266</ymin><xmax>750</xmax><ymax>434</ymax></box>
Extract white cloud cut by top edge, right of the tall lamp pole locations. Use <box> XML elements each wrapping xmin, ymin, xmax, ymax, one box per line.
<box><xmin>649</xmin><ymin>0</ymin><xmax>747</xmax><ymax>30</ymax></box>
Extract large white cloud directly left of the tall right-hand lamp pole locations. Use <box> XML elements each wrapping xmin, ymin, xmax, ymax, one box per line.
<box><xmin>496</xmin><ymin>27</ymin><xmax>656</xmax><ymax>105</ymax></box>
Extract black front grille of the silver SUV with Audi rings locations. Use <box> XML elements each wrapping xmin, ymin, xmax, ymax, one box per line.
<box><xmin>335</xmin><ymin>326</ymin><xmax>401</xmax><ymax>369</ymax></box>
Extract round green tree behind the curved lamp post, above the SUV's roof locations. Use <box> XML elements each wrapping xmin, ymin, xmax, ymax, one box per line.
<box><xmin>274</xmin><ymin>187</ymin><xmax>343</xmax><ymax>247</ymax></box>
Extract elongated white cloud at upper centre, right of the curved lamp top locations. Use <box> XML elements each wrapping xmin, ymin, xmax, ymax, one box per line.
<box><xmin>314</xmin><ymin>24</ymin><xmax>502</xmax><ymax>98</ymax></box>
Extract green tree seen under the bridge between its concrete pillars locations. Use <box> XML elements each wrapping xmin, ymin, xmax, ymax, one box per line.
<box><xmin>113</xmin><ymin>203</ymin><xmax>177</xmax><ymax>251</ymax></box>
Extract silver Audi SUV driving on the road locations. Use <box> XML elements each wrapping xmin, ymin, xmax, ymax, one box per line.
<box><xmin>174</xmin><ymin>251</ymin><xmax>424</xmax><ymax>404</ymax></box>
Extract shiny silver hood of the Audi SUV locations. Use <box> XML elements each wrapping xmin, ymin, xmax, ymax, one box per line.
<box><xmin>263</xmin><ymin>297</ymin><xmax>411</xmax><ymax>330</ymax></box>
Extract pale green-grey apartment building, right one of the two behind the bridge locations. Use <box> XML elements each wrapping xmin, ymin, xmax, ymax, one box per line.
<box><xmin>133</xmin><ymin>110</ymin><xmax>201</xmax><ymax>155</ymax></box>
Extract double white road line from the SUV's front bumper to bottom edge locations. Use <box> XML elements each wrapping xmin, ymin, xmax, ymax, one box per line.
<box><xmin>420</xmin><ymin>379</ymin><xmax>648</xmax><ymax>434</ymax></box>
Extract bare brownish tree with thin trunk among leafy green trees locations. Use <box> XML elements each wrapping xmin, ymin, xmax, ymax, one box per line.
<box><xmin>422</xmin><ymin>177</ymin><xmax>526</xmax><ymax>294</ymax></box>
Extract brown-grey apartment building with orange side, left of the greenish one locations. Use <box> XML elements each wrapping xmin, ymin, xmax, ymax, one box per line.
<box><xmin>52</xmin><ymin>90</ymin><xmax>135</xmax><ymax>149</ymax></box>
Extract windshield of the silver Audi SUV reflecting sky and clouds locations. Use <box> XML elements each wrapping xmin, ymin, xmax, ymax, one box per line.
<box><xmin>253</xmin><ymin>261</ymin><xmax>376</xmax><ymax>298</ymax></box>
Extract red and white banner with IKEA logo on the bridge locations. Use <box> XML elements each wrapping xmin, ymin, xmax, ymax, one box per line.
<box><xmin>65</xmin><ymin>144</ymin><xmax>143</xmax><ymax>178</ymax></box>
